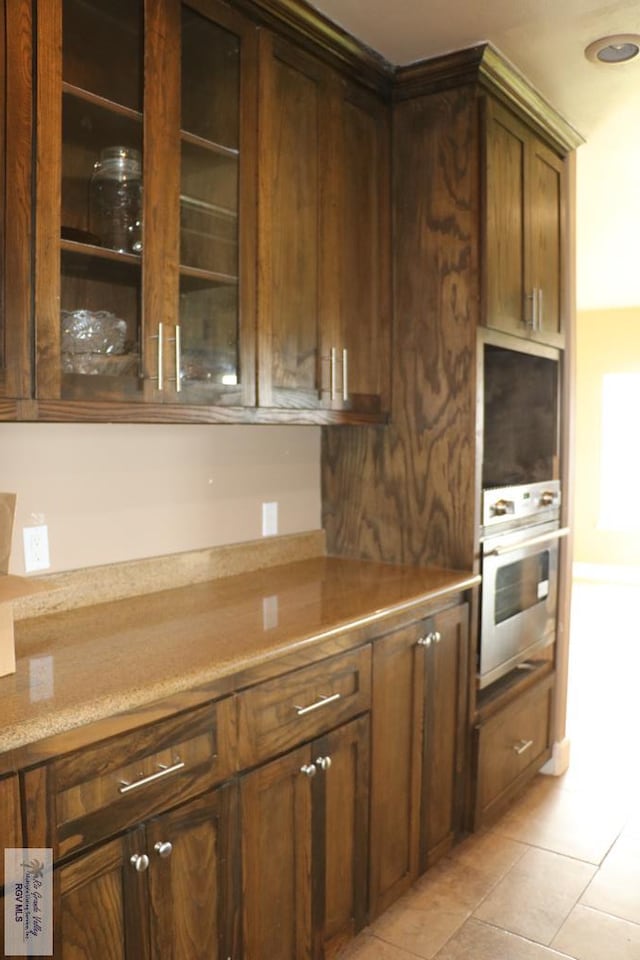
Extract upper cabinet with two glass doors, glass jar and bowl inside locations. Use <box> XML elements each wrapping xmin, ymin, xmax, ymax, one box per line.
<box><xmin>36</xmin><ymin>0</ymin><xmax>256</xmax><ymax>419</ymax></box>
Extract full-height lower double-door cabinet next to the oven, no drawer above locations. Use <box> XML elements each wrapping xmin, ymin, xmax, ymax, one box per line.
<box><xmin>370</xmin><ymin>603</ymin><xmax>469</xmax><ymax>917</ymax></box>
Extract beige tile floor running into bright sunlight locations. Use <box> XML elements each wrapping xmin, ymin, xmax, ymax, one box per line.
<box><xmin>340</xmin><ymin>582</ymin><xmax>640</xmax><ymax>960</ymax></box>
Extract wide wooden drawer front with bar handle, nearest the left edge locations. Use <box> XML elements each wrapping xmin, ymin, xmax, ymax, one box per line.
<box><xmin>25</xmin><ymin>698</ymin><xmax>235</xmax><ymax>857</ymax></box>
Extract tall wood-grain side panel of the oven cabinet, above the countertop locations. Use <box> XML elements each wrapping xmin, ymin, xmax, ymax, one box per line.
<box><xmin>322</xmin><ymin>89</ymin><xmax>479</xmax><ymax>569</ymax></box>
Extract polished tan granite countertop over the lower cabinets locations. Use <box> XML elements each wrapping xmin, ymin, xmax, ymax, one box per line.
<box><xmin>0</xmin><ymin>556</ymin><xmax>479</xmax><ymax>767</ymax></box>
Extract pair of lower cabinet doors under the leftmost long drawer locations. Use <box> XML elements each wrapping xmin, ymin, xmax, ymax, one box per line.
<box><xmin>54</xmin><ymin>784</ymin><xmax>238</xmax><ymax>960</ymax></box>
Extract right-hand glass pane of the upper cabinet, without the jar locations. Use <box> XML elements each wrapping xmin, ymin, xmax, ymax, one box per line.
<box><xmin>179</xmin><ymin>5</ymin><xmax>254</xmax><ymax>402</ymax></box>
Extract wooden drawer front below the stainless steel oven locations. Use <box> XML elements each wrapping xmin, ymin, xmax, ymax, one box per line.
<box><xmin>477</xmin><ymin>679</ymin><xmax>552</xmax><ymax>812</ymax></box>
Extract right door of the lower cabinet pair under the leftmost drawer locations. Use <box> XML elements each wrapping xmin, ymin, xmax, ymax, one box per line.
<box><xmin>146</xmin><ymin>784</ymin><xmax>239</xmax><ymax>960</ymax></box>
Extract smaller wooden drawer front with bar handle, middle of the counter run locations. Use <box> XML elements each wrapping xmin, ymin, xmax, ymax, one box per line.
<box><xmin>238</xmin><ymin>646</ymin><xmax>371</xmax><ymax>770</ymax></box>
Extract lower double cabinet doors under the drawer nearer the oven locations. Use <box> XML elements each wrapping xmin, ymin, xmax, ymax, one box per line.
<box><xmin>240</xmin><ymin>715</ymin><xmax>369</xmax><ymax>960</ymax></box>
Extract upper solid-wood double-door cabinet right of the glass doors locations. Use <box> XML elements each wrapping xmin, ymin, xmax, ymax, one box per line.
<box><xmin>258</xmin><ymin>32</ymin><xmax>391</xmax><ymax>414</ymax></box>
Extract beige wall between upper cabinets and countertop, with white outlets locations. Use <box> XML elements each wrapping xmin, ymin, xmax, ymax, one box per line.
<box><xmin>0</xmin><ymin>423</ymin><xmax>320</xmax><ymax>574</ymax></box>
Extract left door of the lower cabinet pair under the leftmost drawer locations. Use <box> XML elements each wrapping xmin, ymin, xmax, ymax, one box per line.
<box><xmin>53</xmin><ymin>829</ymin><xmax>149</xmax><ymax>960</ymax></box>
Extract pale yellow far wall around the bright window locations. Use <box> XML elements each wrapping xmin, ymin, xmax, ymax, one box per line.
<box><xmin>574</xmin><ymin>307</ymin><xmax>640</xmax><ymax>565</ymax></box>
